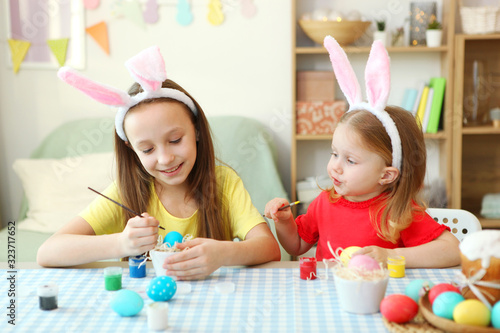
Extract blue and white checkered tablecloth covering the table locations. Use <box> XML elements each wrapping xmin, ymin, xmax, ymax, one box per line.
<box><xmin>0</xmin><ymin>267</ymin><xmax>456</xmax><ymax>332</ymax></box>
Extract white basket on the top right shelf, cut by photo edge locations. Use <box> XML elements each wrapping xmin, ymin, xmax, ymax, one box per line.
<box><xmin>459</xmin><ymin>0</ymin><xmax>500</xmax><ymax>34</ymax></box>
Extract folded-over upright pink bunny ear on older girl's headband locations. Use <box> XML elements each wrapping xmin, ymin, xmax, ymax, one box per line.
<box><xmin>125</xmin><ymin>46</ymin><xmax>167</xmax><ymax>92</ymax></box>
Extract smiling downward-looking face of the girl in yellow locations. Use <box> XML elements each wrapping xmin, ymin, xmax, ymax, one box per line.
<box><xmin>124</xmin><ymin>101</ymin><xmax>197</xmax><ymax>188</ymax></box>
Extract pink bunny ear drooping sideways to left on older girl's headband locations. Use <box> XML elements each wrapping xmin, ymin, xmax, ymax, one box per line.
<box><xmin>57</xmin><ymin>67</ymin><xmax>130</xmax><ymax>106</ymax></box>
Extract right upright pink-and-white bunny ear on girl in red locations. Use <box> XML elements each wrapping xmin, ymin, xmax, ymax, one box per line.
<box><xmin>365</xmin><ymin>40</ymin><xmax>391</xmax><ymax>110</ymax></box>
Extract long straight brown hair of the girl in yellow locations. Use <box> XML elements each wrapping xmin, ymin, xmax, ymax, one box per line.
<box><xmin>115</xmin><ymin>80</ymin><xmax>232</xmax><ymax>240</ymax></box>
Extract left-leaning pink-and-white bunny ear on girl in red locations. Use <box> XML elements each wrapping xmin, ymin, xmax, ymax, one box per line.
<box><xmin>323</xmin><ymin>36</ymin><xmax>362</xmax><ymax>106</ymax></box>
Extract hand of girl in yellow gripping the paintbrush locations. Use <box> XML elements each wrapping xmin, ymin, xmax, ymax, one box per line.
<box><xmin>119</xmin><ymin>213</ymin><xmax>160</xmax><ymax>257</ymax></box>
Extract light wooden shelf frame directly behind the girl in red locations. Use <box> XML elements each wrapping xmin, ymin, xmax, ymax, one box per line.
<box><xmin>291</xmin><ymin>0</ymin><xmax>456</xmax><ymax>213</ymax></box>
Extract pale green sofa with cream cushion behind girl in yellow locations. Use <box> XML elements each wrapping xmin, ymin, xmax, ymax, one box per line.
<box><xmin>0</xmin><ymin>116</ymin><xmax>290</xmax><ymax>262</ymax></box>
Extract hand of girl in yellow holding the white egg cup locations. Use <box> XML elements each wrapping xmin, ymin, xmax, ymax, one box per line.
<box><xmin>163</xmin><ymin>238</ymin><xmax>227</xmax><ymax>280</ymax></box>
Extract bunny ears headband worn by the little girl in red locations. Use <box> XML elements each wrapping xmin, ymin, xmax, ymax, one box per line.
<box><xmin>324</xmin><ymin>36</ymin><xmax>402</xmax><ymax>170</ymax></box>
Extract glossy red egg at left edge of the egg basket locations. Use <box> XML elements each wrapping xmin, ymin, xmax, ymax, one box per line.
<box><xmin>380</xmin><ymin>294</ymin><xmax>418</xmax><ymax>323</ymax></box>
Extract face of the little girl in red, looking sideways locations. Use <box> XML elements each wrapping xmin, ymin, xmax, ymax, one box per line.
<box><xmin>327</xmin><ymin>123</ymin><xmax>392</xmax><ymax>202</ymax></box>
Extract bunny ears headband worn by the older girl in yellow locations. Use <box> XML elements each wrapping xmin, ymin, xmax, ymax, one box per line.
<box><xmin>57</xmin><ymin>46</ymin><xmax>198</xmax><ymax>141</ymax></box>
